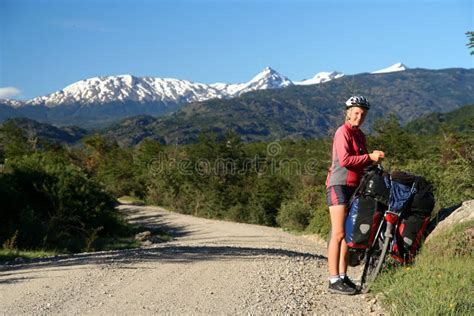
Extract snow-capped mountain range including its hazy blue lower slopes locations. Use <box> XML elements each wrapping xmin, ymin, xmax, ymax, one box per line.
<box><xmin>0</xmin><ymin>63</ymin><xmax>412</xmax><ymax>127</ymax></box>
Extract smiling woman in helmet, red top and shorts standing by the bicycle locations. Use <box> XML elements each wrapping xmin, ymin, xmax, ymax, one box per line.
<box><xmin>326</xmin><ymin>96</ymin><xmax>385</xmax><ymax>295</ymax></box>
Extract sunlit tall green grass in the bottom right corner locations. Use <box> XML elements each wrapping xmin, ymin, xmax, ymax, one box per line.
<box><xmin>372</xmin><ymin>221</ymin><xmax>474</xmax><ymax>315</ymax></box>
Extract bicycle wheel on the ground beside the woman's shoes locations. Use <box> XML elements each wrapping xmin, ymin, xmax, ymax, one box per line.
<box><xmin>361</xmin><ymin>233</ymin><xmax>392</xmax><ymax>293</ymax></box>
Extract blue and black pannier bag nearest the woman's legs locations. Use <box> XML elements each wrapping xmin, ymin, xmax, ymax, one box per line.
<box><xmin>344</xmin><ymin>196</ymin><xmax>383</xmax><ymax>249</ymax></box>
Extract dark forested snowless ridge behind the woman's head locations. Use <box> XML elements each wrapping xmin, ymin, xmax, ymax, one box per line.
<box><xmin>100</xmin><ymin>68</ymin><xmax>474</xmax><ymax>145</ymax></box>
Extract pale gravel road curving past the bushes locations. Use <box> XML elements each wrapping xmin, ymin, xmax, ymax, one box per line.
<box><xmin>0</xmin><ymin>205</ymin><xmax>383</xmax><ymax>315</ymax></box>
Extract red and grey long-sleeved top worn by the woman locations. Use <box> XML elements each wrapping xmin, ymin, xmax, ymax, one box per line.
<box><xmin>326</xmin><ymin>122</ymin><xmax>372</xmax><ymax>187</ymax></box>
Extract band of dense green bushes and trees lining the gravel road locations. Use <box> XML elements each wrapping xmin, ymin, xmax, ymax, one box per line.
<box><xmin>0</xmin><ymin>106</ymin><xmax>474</xmax><ymax>266</ymax></box>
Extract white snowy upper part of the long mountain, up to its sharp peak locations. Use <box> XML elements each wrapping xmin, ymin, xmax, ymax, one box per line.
<box><xmin>0</xmin><ymin>67</ymin><xmax>293</xmax><ymax>108</ymax></box>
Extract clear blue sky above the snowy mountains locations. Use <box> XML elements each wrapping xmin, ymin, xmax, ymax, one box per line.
<box><xmin>0</xmin><ymin>0</ymin><xmax>474</xmax><ymax>99</ymax></box>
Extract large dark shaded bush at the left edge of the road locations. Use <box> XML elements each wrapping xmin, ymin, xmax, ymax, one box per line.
<box><xmin>0</xmin><ymin>152</ymin><xmax>125</xmax><ymax>251</ymax></box>
